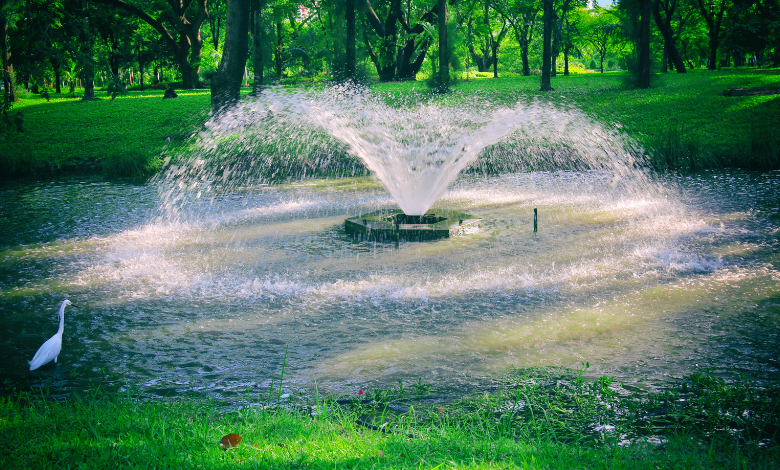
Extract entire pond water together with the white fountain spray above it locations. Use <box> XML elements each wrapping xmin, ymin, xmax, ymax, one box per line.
<box><xmin>0</xmin><ymin>83</ymin><xmax>780</xmax><ymax>403</ymax></box>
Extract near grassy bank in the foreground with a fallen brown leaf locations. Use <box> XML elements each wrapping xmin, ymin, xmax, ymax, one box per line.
<box><xmin>0</xmin><ymin>369</ymin><xmax>780</xmax><ymax>469</ymax></box>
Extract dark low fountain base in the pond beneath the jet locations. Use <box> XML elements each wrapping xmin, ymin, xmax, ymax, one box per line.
<box><xmin>344</xmin><ymin>209</ymin><xmax>482</xmax><ymax>241</ymax></box>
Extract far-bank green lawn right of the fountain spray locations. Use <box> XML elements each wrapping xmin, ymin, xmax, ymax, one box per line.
<box><xmin>375</xmin><ymin>68</ymin><xmax>780</xmax><ymax>170</ymax></box>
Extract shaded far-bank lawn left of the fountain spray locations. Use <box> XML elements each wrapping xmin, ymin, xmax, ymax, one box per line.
<box><xmin>0</xmin><ymin>89</ymin><xmax>210</xmax><ymax>177</ymax></box>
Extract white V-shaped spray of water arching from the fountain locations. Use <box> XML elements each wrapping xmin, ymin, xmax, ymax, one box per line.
<box><xmin>157</xmin><ymin>87</ymin><xmax>641</xmax><ymax>215</ymax></box>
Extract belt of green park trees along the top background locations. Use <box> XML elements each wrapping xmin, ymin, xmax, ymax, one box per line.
<box><xmin>0</xmin><ymin>0</ymin><xmax>780</xmax><ymax>103</ymax></box>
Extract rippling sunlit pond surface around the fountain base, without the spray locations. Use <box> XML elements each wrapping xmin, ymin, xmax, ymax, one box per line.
<box><xmin>0</xmin><ymin>171</ymin><xmax>780</xmax><ymax>397</ymax></box>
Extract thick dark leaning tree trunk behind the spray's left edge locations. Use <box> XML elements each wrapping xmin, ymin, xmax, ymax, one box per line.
<box><xmin>211</xmin><ymin>0</ymin><xmax>250</xmax><ymax>114</ymax></box>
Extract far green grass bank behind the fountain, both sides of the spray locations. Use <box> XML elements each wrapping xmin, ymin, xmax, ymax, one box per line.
<box><xmin>0</xmin><ymin>68</ymin><xmax>780</xmax><ymax>179</ymax></box>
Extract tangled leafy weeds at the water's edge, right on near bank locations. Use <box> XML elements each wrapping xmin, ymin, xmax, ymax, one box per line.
<box><xmin>482</xmin><ymin>368</ymin><xmax>780</xmax><ymax>448</ymax></box>
